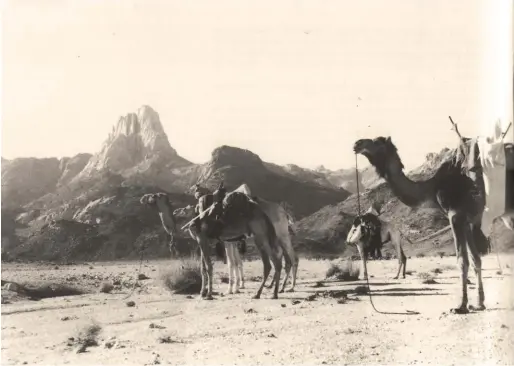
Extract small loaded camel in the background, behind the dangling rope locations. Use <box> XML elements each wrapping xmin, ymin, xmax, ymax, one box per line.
<box><xmin>346</xmin><ymin>211</ymin><xmax>412</xmax><ymax>279</ymax></box>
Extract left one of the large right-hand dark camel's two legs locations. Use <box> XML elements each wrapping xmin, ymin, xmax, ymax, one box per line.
<box><xmin>448</xmin><ymin>212</ymin><xmax>469</xmax><ymax>314</ymax></box>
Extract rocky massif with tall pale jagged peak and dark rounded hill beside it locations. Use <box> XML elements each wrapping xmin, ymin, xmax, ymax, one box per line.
<box><xmin>2</xmin><ymin>106</ymin><xmax>349</xmax><ymax>261</ymax></box>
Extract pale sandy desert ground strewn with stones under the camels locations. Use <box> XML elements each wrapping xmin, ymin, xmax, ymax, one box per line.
<box><xmin>1</xmin><ymin>255</ymin><xmax>514</xmax><ymax>365</ymax></box>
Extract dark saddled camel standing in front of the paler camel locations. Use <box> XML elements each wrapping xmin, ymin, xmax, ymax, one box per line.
<box><xmin>141</xmin><ymin>192</ymin><xmax>283</xmax><ymax>300</ymax></box>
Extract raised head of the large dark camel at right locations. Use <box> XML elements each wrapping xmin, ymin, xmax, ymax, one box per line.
<box><xmin>353</xmin><ymin>136</ymin><xmax>403</xmax><ymax>178</ymax></box>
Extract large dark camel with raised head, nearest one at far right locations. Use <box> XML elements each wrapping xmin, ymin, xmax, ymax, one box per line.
<box><xmin>353</xmin><ymin>137</ymin><xmax>488</xmax><ymax>314</ymax></box>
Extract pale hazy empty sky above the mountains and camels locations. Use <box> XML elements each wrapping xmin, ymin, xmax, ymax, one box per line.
<box><xmin>1</xmin><ymin>0</ymin><xmax>512</xmax><ymax>168</ymax></box>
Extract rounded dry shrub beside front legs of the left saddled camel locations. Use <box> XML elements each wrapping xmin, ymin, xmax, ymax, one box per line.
<box><xmin>160</xmin><ymin>259</ymin><xmax>202</xmax><ymax>294</ymax></box>
